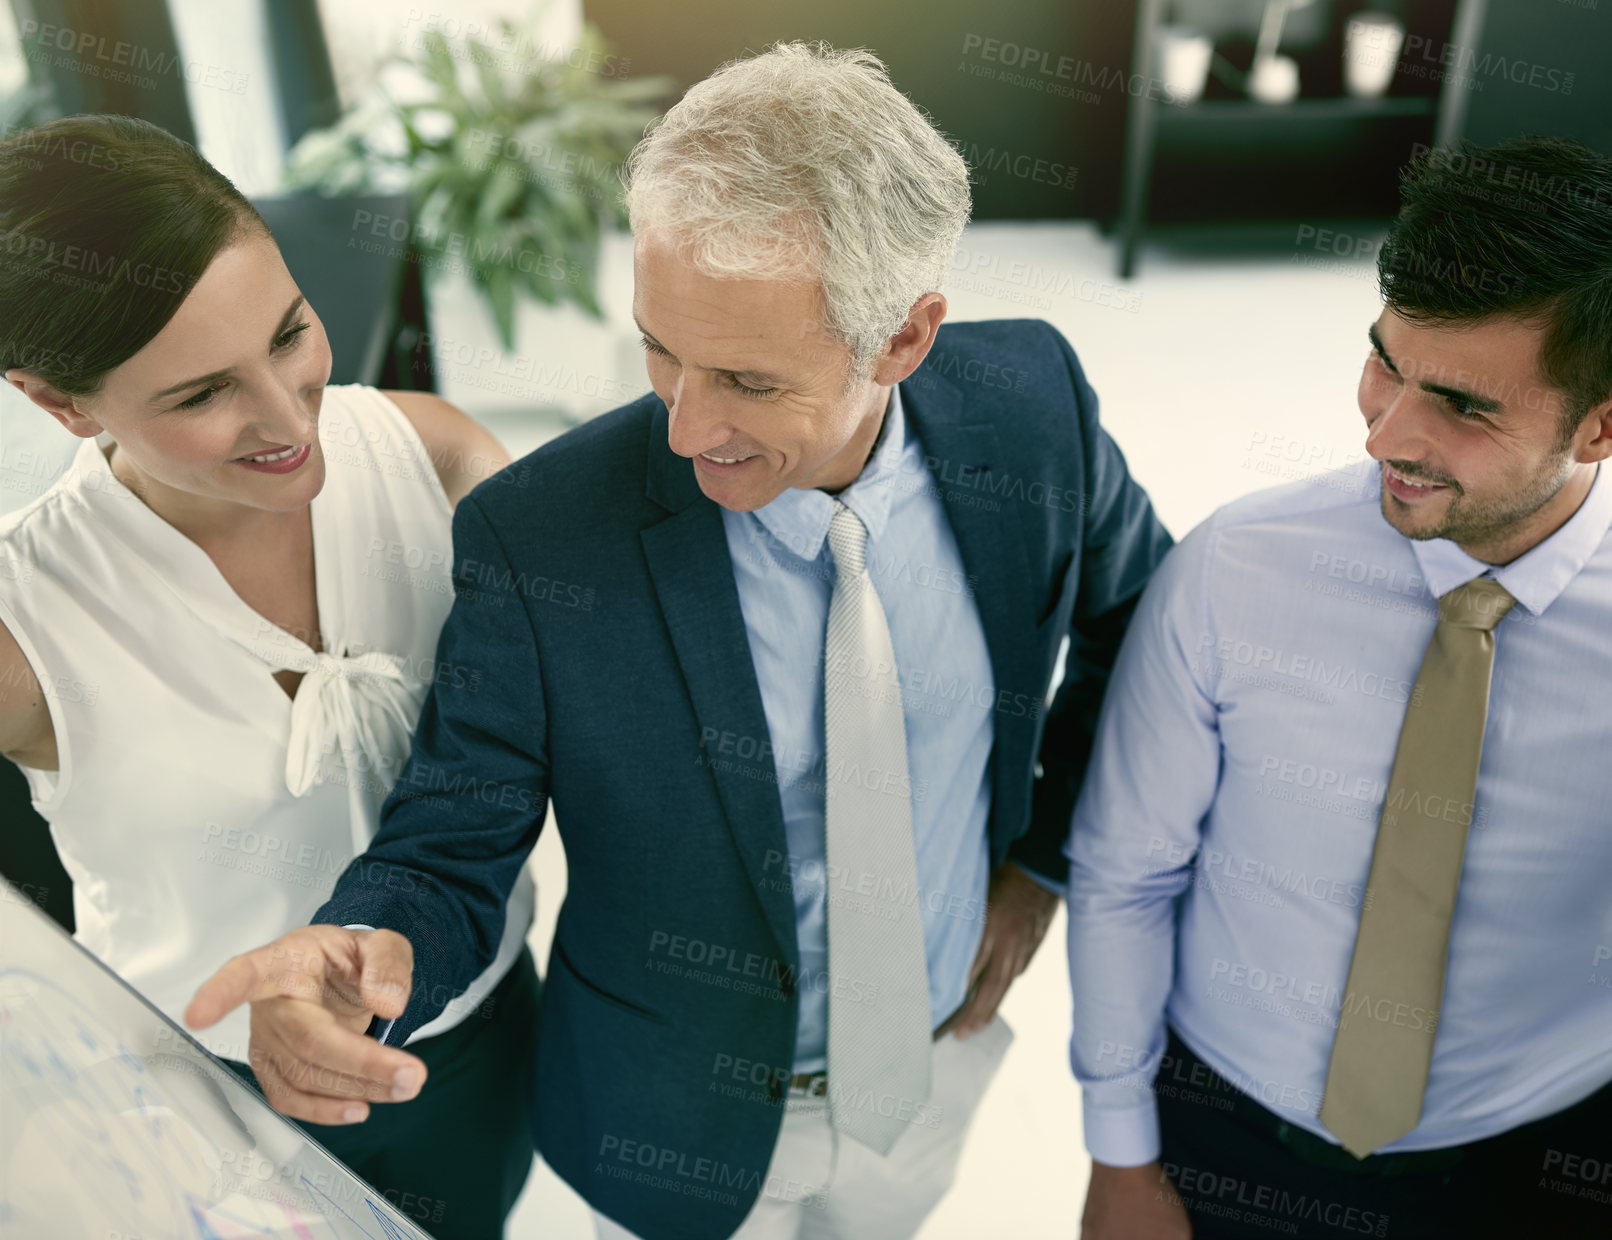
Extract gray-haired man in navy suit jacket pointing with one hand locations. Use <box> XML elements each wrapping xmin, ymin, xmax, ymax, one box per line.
<box><xmin>190</xmin><ymin>44</ymin><xmax>1169</xmax><ymax>1240</ymax></box>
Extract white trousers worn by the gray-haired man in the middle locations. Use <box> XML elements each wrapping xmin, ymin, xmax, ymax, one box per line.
<box><xmin>593</xmin><ymin>1016</ymin><xmax>1012</xmax><ymax>1240</ymax></box>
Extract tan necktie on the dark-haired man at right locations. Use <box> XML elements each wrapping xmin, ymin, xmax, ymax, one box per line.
<box><xmin>1319</xmin><ymin>577</ymin><xmax>1517</xmax><ymax>1158</ymax></box>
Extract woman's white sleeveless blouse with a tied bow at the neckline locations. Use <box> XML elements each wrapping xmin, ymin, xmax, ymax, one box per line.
<box><xmin>0</xmin><ymin>385</ymin><xmax>534</xmax><ymax>1059</ymax></box>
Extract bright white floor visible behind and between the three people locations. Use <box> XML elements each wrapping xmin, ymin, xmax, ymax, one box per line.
<box><xmin>0</xmin><ymin>224</ymin><xmax>1378</xmax><ymax>1240</ymax></box>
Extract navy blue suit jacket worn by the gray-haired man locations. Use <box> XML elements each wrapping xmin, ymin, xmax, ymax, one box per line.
<box><xmin>314</xmin><ymin>321</ymin><xmax>1170</xmax><ymax>1240</ymax></box>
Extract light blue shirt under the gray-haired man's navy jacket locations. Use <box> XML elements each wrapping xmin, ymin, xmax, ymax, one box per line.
<box><xmin>722</xmin><ymin>387</ymin><xmax>996</xmax><ymax>1072</ymax></box>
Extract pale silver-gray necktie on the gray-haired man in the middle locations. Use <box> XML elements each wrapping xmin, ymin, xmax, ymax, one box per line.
<box><xmin>824</xmin><ymin>503</ymin><xmax>933</xmax><ymax>1155</ymax></box>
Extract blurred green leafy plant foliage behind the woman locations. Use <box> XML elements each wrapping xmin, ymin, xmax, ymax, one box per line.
<box><xmin>287</xmin><ymin>19</ymin><xmax>674</xmax><ymax>416</ymax></box>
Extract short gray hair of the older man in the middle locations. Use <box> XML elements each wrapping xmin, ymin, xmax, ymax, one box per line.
<box><xmin>625</xmin><ymin>42</ymin><xmax>969</xmax><ymax>372</ymax></box>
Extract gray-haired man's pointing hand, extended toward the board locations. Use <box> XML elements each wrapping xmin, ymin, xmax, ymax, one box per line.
<box><xmin>185</xmin><ymin>926</ymin><xmax>426</xmax><ymax>1124</ymax></box>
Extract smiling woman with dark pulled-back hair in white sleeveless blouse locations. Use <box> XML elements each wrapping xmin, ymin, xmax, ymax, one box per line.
<box><xmin>0</xmin><ymin>116</ymin><xmax>537</xmax><ymax>1237</ymax></box>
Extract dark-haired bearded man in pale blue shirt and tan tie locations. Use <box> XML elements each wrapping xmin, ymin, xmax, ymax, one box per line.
<box><xmin>1069</xmin><ymin>139</ymin><xmax>1612</xmax><ymax>1240</ymax></box>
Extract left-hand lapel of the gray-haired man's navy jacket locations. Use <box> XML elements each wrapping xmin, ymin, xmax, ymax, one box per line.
<box><xmin>640</xmin><ymin>408</ymin><xmax>800</xmax><ymax>971</ymax></box>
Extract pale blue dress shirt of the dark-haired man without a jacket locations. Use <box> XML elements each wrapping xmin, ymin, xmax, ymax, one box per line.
<box><xmin>1069</xmin><ymin>461</ymin><xmax>1612</xmax><ymax>1166</ymax></box>
